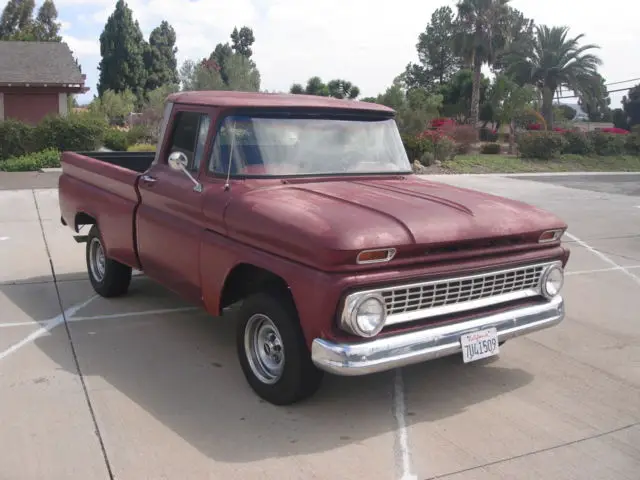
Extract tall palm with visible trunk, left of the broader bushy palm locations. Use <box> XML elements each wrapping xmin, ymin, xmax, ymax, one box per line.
<box><xmin>454</xmin><ymin>0</ymin><xmax>510</xmax><ymax>126</ymax></box>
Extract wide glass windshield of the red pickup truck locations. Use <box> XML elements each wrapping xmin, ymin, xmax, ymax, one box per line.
<box><xmin>209</xmin><ymin>116</ymin><xmax>411</xmax><ymax>176</ymax></box>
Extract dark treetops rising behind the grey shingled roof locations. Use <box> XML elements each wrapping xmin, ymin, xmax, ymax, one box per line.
<box><xmin>0</xmin><ymin>0</ymin><xmax>62</xmax><ymax>42</ymax></box>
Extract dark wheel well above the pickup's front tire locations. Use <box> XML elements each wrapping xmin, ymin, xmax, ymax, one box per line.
<box><xmin>220</xmin><ymin>263</ymin><xmax>291</xmax><ymax>313</ymax></box>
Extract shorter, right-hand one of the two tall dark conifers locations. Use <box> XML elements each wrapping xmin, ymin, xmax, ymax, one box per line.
<box><xmin>144</xmin><ymin>21</ymin><xmax>179</xmax><ymax>92</ymax></box>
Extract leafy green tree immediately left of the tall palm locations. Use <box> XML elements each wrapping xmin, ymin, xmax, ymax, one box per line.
<box><xmin>404</xmin><ymin>6</ymin><xmax>460</xmax><ymax>88</ymax></box>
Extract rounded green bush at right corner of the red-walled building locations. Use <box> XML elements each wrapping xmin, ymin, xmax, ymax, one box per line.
<box><xmin>35</xmin><ymin>114</ymin><xmax>107</xmax><ymax>151</ymax></box>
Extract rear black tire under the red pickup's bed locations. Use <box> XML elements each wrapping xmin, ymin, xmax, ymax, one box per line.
<box><xmin>86</xmin><ymin>225</ymin><xmax>131</xmax><ymax>298</ymax></box>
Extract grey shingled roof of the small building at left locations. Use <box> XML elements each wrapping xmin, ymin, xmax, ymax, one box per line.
<box><xmin>0</xmin><ymin>41</ymin><xmax>84</xmax><ymax>85</ymax></box>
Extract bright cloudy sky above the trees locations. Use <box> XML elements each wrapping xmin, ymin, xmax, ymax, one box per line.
<box><xmin>6</xmin><ymin>0</ymin><xmax>640</xmax><ymax>108</ymax></box>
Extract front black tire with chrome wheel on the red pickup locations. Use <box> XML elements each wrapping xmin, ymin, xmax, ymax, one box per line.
<box><xmin>236</xmin><ymin>293</ymin><xmax>323</xmax><ymax>405</ymax></box>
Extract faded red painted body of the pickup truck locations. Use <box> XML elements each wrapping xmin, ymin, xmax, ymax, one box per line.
<box><xmin>59</xmin><ymin>92</ymin><xmax>569</xmax><ymax>346</ymax></box>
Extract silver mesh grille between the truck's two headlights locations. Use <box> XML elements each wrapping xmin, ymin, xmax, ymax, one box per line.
<box><xmin>381</xmin><ymin>264</ymin><xmax>548</xmax><ymax>324</ymax></box>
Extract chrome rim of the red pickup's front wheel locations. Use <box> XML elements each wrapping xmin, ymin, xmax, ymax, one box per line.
<box><xmin>244</xmin><ymin>313</ymin><xmax>284</xmax><ymax>384</ymax></box>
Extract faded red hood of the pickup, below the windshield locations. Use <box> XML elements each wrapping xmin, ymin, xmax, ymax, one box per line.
<box><xmin>225</xmin><ymin>177</ymin><xmax>566</xmax><ymax>267</ymax></box>
